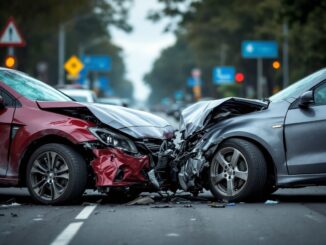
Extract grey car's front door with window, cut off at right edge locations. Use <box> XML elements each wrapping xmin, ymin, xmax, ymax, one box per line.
<box><xmin>284</xmin><ymin>82</ymin><xmax>326</xmax><ymax>174</ymax></box>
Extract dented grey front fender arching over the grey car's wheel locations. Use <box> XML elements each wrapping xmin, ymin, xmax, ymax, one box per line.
<box><xmin>197</xmin><ymin>113</ymin><xmax>288</xmax><ymax>174</ymax></box>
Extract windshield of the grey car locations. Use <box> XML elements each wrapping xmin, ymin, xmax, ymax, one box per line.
<box><xmin>269</xmin><ymin>70</ymin><xmax>325</xmax><ymax>102</ymax></box>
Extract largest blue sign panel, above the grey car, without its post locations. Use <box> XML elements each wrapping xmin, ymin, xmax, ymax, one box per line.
<box><xmin>241</xmin><ymin>41</ymin><xmax>278</xmax><ymax>59</ymax></box>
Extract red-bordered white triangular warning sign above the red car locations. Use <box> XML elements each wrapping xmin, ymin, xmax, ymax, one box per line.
<box><xmin>0</xmin><ymin>17</ymin><xmax>25</xmax><ymax>47</ymax></box>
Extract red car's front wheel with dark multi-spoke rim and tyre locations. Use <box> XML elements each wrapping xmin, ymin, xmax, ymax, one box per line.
<box><xmin>26</xmin><ymin>143</ymin><xmax>87</xmax><ymax>205</ymax></box>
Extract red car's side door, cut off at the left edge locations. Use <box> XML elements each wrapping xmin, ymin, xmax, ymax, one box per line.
<box><xmin>0</xmin><ymin>88</ymin><xmax>15</xmax><ymax>176</ymax></box>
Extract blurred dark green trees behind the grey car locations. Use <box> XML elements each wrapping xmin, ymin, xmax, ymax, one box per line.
<box><xmin>149</xmin><ymin>0</ymin><xmax>326</xmax><ymax>101</ymax></box>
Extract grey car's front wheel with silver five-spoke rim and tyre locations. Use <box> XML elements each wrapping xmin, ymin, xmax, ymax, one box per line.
<box><xmin>209</xmin><ymin>139</ymin><xmax>267</xmax><ymax>201</ymax></box>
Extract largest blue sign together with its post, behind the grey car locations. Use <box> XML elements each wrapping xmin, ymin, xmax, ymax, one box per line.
<box><xmin>241</xmin><ymin>41</ymin><xmax>278</xmax><ymax>98</ymax></box>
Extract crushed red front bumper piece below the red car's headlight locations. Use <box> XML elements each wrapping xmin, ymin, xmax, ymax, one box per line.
<box><xmin>91</xmin><ymin>148</ymin><xmax>150</xmax><ymax>187</ymax></box>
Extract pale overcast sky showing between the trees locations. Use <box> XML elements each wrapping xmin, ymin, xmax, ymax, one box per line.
<box><xmin>112</xmin><ymin>0</ymin><xmax>175</xmax><ymax>100</ymax></box>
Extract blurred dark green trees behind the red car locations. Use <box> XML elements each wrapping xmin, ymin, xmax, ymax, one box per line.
<box><xmin>0</xmin><ymin>0</ymin><xmax>132</xmax><ymax>99</ymax></box>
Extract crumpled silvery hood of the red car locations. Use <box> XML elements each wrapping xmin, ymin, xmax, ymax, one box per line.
<box><xmin>37</xmin><ymin>101</ymin><xmax>175</xmax><ymax>139</ymax></box>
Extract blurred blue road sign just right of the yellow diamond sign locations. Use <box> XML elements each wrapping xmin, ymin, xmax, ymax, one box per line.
<box><xmin>82</xmin><ymin>55</ymin><xmax>112</xmax><ymax>72</ymax></box>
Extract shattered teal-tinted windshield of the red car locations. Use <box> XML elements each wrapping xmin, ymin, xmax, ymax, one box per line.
<box><xmin>0</xmin><ymin>70</ymin><xmax>72</xmax><ymax>101</ymax></box>
